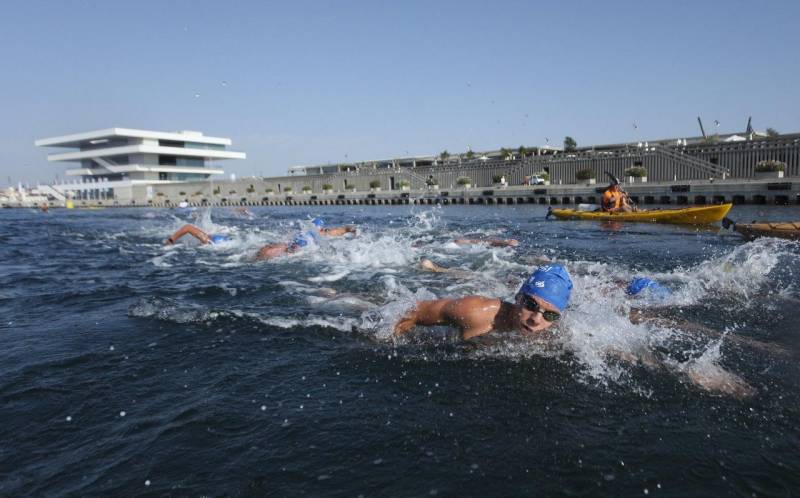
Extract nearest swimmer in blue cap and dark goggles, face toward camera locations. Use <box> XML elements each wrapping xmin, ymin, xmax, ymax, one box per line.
<box><xmin>394</xmin><ymin>264</ymin><xmax>572</xmax><ymax>339</ymax></box>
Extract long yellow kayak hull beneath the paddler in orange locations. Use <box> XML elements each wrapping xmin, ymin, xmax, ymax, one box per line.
<box><xmin>550</xmin><ymin>204</ymin><xmax>733</xmax><ymax>225</ymax></box>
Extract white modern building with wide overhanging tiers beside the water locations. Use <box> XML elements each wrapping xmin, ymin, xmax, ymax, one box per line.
<box><xmin>34</xmin><ymin>128</ymin><xmax>247</xmax><ymax>204</ymax></box>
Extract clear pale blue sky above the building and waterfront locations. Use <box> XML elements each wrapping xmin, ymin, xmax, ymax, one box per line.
<box><xmin>0</xmin><ymin>0</ymin><xmax>800</xmax><ymax>185</ymax></box>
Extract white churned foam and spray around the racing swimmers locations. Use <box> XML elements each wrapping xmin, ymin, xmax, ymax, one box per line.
<box><xmin>131</xmin><ymin>208</ymin><xmax>798</xmax><ymax>393</ymax></box>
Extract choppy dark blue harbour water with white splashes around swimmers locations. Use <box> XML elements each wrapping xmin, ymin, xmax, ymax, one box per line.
<box><xmin>0</xmin><ymin>206</ymin><xmax>800</xmax><ymax>496</ymax></box>
